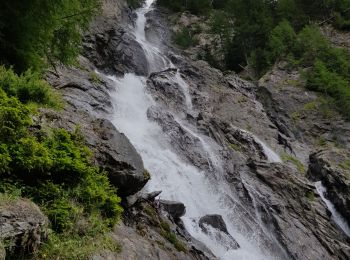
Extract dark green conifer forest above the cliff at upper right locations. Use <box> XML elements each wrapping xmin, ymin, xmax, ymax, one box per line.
<box><xmin>158</xmin><ymin>0</ymin><xmax>350</xmax><ymax>117</ymax></box>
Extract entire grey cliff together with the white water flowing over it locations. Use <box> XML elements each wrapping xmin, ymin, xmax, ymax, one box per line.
<box><xmin>36</xmin><ymin>0</ymin><xmax>350</xmax><ymax>260</ymax></box>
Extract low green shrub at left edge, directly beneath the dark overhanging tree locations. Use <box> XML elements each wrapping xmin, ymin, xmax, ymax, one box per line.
<box><xmin>0</xmin><ymin>66</ymin><xmax>60</xmax><ymax>108</ymax></box>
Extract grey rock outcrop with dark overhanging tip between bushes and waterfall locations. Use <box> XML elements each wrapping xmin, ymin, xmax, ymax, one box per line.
<box><xmin>44</xmin><ymin>59</ymin><xmax>149</xmax><ymax>197</ymax></box>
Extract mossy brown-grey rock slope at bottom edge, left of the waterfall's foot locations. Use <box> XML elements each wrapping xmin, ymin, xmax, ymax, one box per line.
<box><xmin>112</xmin><ymin>201</ymin><xmax>215</xmax><ymax>260</ymax></box>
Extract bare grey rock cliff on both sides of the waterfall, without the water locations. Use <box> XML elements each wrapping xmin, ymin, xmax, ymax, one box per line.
<box><xmin>0</xmin><ymin>0</ymin><xmax>350</xmax><ymax>259</ymax></box>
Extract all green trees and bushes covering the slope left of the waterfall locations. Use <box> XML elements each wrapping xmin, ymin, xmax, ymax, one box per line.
<box><xmin>0</xmin><ymin>0</ymin><xmax>122</xmax><ymax>259</ymax></box>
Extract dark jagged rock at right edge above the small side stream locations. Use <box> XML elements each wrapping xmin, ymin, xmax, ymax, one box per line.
<box><xmin>308</xmin><ymin>150</ymin><xmax>350</xmax><ymax>228</ymax></box>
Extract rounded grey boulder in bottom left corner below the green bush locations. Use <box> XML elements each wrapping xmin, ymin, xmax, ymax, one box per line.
<box><xmin>0</xmin><ymin>200</ymin><xmax>49</xmax><ymax>259</ymax></box>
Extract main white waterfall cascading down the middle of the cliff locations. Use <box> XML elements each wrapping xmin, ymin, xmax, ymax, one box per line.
<box><xmin>111</xmin><ymin>0</ymin><xmax>284</xmax><ymax>260</ymax></box>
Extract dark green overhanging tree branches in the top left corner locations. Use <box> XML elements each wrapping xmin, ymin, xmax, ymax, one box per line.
<box><xmin>0</xmin><ymin>0</ymin><xmax>99</xmax><ymax>71</ymax></box>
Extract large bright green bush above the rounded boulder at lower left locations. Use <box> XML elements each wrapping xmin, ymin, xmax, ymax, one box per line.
<box><xmin>0</xmin><ymin>86</ymin><xmax>122</xmax><ymax>259</ymax></box>
